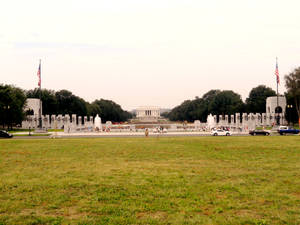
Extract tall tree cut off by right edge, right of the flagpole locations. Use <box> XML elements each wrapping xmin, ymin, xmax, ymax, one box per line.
<box><xmin>284</xmin><ymin>67</ymin><xmax>300</xmax><ymax>118</ymax></box>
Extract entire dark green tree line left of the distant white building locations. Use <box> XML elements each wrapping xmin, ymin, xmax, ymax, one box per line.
<box><xmin>0</xmin><ymin>84</ymin><xmax>132</xmax><ymax>128</ymax></box>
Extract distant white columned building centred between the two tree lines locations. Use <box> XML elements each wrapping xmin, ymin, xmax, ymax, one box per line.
<box><xmin>136</xmin><ymin>106</ymin><xmax>160</xmax><ymax>122</ymax></box>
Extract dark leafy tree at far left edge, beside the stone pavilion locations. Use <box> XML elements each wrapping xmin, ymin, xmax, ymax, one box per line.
<box><xmin>0</xmin><ymin>85</ymin><xmax>26</xmax><ymax>128</ymax></box>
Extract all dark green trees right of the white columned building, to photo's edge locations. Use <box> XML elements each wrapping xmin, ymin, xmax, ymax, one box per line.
<box><xmin>162</xmin><ymin>67</ymin><xmax>300</xmax><ymax>123</ymax></box>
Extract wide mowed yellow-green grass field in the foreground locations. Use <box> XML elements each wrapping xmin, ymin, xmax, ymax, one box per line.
<box><xmin>0</xmin><ymin>136</ymin><xmax>300</xmax><ymax>224</ymax></box>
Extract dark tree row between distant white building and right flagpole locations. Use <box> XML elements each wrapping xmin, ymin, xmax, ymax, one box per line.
<box><xmin>164</xmin><ymin>85</ymin><xmax>276</xmax><ymax>122</ymax></box>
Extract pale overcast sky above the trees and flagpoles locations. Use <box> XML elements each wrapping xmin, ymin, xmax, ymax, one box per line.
<box><xmin>0</xmin><ymin>0</ymin><xmax>300</xmax><ymax>110</ymax></box>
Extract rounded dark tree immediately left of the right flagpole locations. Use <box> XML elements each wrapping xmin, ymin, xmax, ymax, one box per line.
<box><xmin>246</xmin><ymin>85</ymin><xmax>276</xmax><ymax>113</ymax></box>
